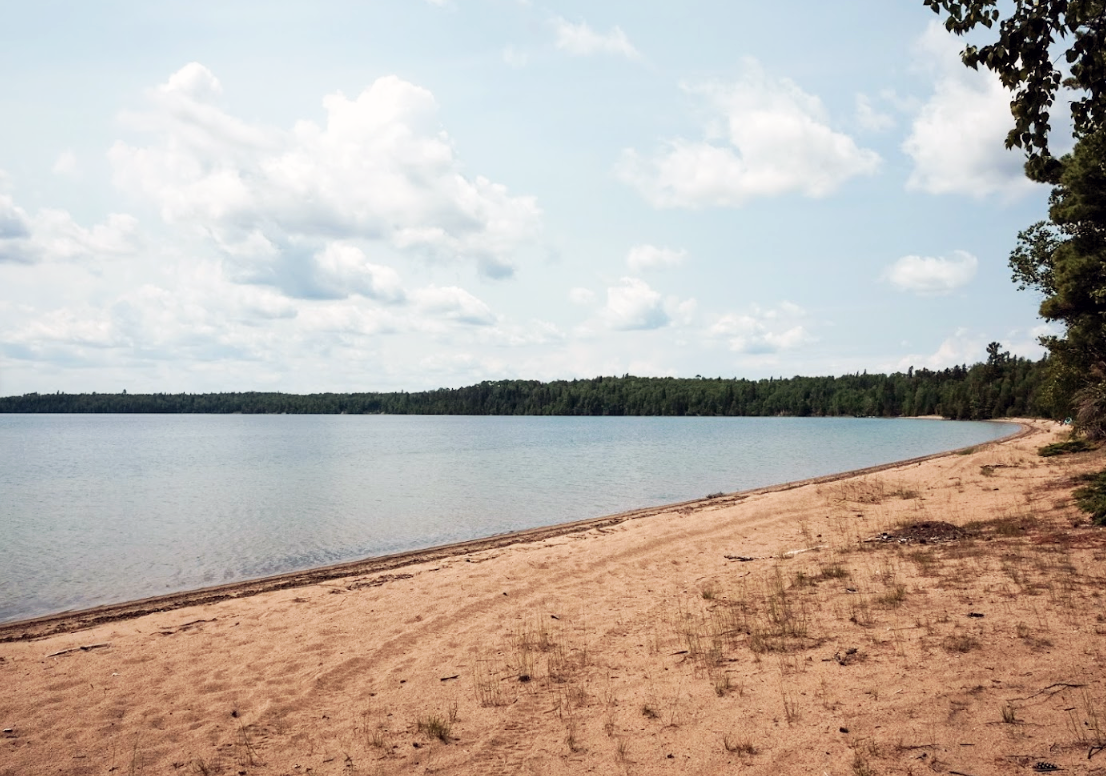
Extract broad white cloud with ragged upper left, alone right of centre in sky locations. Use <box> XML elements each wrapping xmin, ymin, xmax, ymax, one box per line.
<box><xmin>618</xmin><ymin>60</ymin><xmax>880</xmax><ymax>208</ymax></box>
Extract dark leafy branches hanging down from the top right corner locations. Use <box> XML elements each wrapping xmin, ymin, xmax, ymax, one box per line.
<box><xmin>924</xmin><ymin>0</ymin><xmax>1106</xmax><ymax>176</ymax></box>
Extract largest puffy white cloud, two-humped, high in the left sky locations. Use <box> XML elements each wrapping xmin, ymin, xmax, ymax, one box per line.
<box><xmin>108</xmin><ymin>62</ymin><xmax>541</xmax><ymax>285</ymax></box>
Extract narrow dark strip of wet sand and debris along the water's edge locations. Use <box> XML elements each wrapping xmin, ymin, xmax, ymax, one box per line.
<box><xmin>0</xmin><ymin>416</ymin><xmax>1035</xmax><ymax>643</ymax></box>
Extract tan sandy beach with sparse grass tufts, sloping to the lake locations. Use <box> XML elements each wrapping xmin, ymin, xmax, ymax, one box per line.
<box><xmin>0</xmin><ymin>421</ymin><xmax>1106</xmax><ymax>776</ymax></box>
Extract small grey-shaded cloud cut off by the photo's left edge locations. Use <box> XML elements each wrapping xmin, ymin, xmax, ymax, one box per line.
<box><xmin>0</xmin><ymin>195</ymin><xmax>138</xmax><ymax>264</ymax></box>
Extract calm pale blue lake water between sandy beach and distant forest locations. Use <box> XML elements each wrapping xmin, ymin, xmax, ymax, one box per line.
<box><xmin>0</xmin><ymin>415</ymin><xmax>1013</xmax><ymax>621</ymax></box>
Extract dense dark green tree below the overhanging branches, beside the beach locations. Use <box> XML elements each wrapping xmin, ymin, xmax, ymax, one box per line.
<box><xmin>1010</xmin><ymin>129</ymin><xmax>1106</xmax><ymax>439</ymax></box>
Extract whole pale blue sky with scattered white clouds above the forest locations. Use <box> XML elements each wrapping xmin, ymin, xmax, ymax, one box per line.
<box><xmin>0</xmin><ymin>0</ymin><xmax>1064</xmax><ymax>396</ymax></box>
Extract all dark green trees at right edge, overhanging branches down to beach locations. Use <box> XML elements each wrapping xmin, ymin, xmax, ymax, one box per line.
<box><xmin>922</xmin><ymin>0</ymin><xmax>1106</xmax><ymax>438</ymax></box>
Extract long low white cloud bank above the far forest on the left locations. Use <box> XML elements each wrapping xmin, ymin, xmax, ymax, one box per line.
<box><xmin>0</xmin><ymin>260</ymin><xmax>508</xmax><ymax>384</ymax></box>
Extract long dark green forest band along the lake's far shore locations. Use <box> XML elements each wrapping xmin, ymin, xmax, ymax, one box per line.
<box><xmin>0</xmin><ymin>344</ymin><xmax>1050</xmax><ymax>420</ymax></box>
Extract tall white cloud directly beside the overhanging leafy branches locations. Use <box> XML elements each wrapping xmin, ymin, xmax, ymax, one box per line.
<box><xmin>902</xmin><ymin>21</ymin><xmax>1034</xmax><ymax>197</ymax></box>
